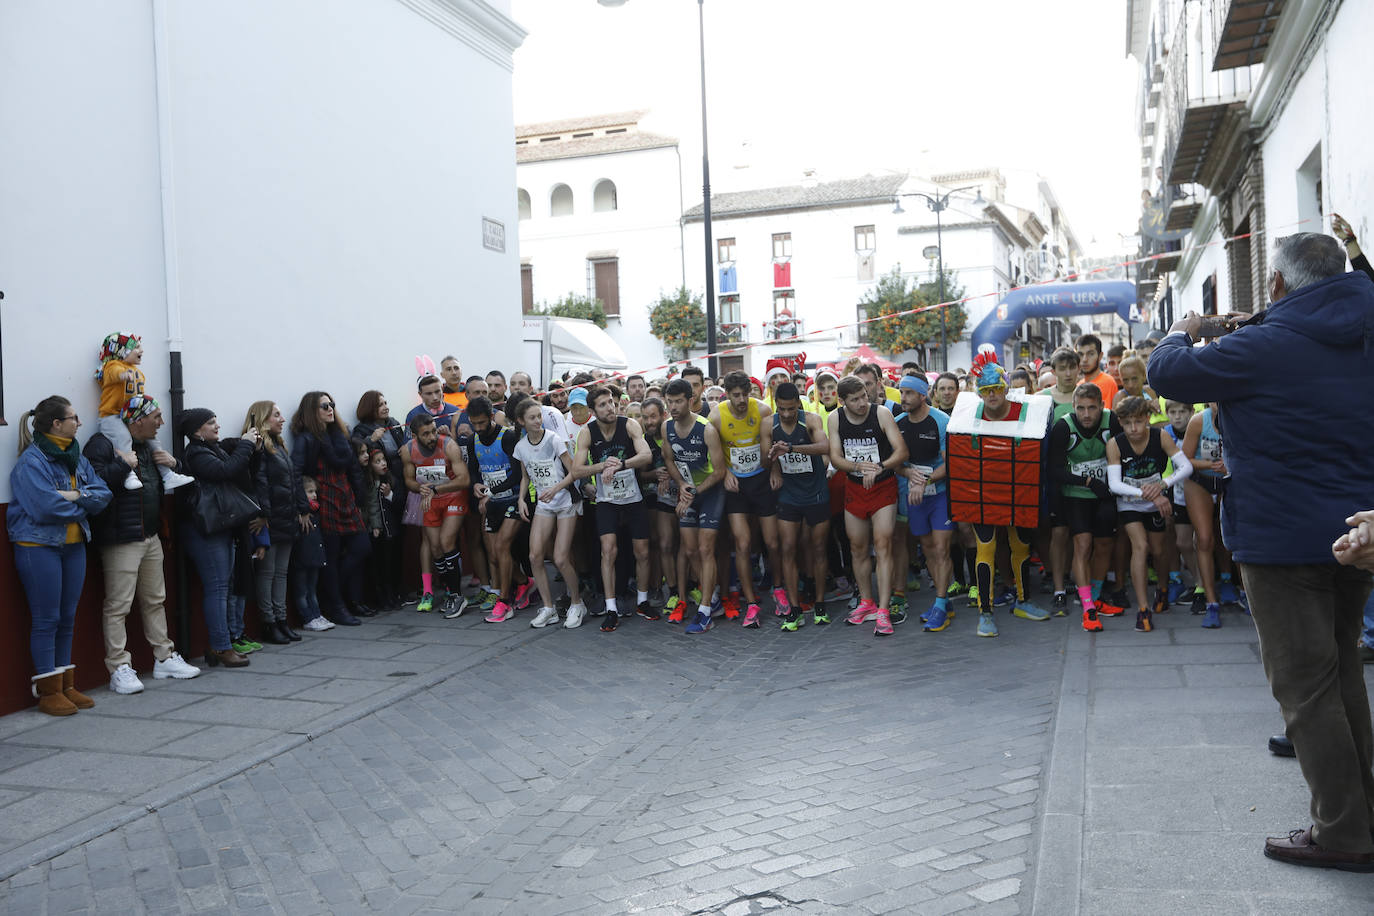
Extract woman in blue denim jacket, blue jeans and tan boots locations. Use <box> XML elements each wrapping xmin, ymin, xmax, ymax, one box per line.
<box><xmin>5</xmin><ymin>394</ymin><xmax>110</xmax><ymax>715</ymax></box>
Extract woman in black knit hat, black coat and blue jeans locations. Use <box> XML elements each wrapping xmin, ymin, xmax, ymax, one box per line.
<box><xmin>177</xmin><ymin>408</ymin><xmax>258</xmax><ymax>667</ymax></box>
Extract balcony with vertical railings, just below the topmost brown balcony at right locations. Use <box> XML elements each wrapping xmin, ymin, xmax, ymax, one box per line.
<box><xmin>1161</xmin><ymin>0</ymin><xmax>1260</xmax><ymax>192</ymax></box>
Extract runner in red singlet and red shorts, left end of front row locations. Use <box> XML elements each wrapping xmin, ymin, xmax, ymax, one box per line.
<box><xmin>401</xmin><ymin>413</ymin><xmax>470</xmax><ymax>619</ymax></box>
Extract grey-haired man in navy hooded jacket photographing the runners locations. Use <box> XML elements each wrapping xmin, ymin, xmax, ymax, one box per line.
<box><xmin>1149</xmin><ymin>232</ymin><xmax>1374</xmax><ymax>872</ymax></box>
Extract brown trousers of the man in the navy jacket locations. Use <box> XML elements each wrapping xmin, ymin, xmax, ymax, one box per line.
<box><xmin>1241</xmin><ymin>563</ymin><xmax>1374</xmax><ymax>853</ymax></box>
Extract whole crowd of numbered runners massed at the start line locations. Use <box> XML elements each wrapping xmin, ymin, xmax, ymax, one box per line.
<box><xmin>401</xmin><ymin>335</ymin><xmax>1243</xmax><ymax>637</ymax></box>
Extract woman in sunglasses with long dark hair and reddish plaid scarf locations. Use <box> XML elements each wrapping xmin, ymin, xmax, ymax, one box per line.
<box><xmin>291</xmin><ymin>391</ymin><xmax>376</xmax><ymax>626</ymax></box>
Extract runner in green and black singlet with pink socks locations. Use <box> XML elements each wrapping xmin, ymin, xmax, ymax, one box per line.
<box><xmin>1050</xmin><ymin>381</ymin><xmax>1124</xmax><ymax>633</ymax></box>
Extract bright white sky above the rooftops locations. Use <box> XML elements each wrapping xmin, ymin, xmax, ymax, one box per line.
<box><xmin>511</xmin><ymin>0</ymin><xmax>1142</xmax><ymax>253</ymax></box>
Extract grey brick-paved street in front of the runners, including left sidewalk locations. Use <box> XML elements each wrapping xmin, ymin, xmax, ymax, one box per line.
<box><xmin>0</xmin><ymin>596</ymin><xmax>1068</xmax><ymax>915</ymax></box>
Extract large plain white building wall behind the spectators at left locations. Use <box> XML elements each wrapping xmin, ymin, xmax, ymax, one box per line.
<box><xmin>0</xmin><ymin>0</ymin><xmax>522</xmax><ymax>499</ymax></box>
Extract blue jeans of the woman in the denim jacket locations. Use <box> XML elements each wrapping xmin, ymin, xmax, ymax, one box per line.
<box><xmin>14</xmin><ymin>542</ymin><xmax>85</xmax><ymax>674</ymax></box>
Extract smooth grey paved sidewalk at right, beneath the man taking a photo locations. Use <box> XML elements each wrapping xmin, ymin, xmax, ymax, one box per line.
<box><xmin>1033</xmin><ymin>607</ymin><xmax>1374</xmax><ymax>916</ymax></box>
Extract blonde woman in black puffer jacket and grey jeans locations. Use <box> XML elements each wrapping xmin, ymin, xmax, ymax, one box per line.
<box><xmin>243</xmin><ymin>401</ymin><xmax>311</xmax><ymax>645</ymax></box>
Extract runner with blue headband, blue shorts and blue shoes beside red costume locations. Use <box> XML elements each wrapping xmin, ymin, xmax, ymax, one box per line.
<box><xmin>897</xmin><ymin>375</ymin><xmax>955</xmax><ymax>633</ymax></box>
